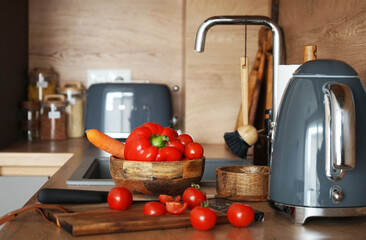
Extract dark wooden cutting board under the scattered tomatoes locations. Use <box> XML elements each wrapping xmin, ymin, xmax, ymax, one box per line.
<box><xmin>47</xmin><ymin>202</ymin><xmax>228</xmax><ymax>236</ymax></box>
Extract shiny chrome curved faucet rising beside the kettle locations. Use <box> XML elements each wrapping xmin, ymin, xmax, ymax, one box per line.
<box><xmin>194</xmin><ymin>16</ymin><xmax>281</xmax><ymax>126</ymax></box>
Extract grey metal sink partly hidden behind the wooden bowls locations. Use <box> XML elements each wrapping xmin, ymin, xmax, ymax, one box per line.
<box><xmin>66</xmin><ymin>157</ymin><xmax>253</xmax><ymax>186</ymax></box>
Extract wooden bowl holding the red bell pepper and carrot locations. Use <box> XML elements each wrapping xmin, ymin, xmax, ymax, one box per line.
<box><xmin>109</xmin><ymin>156</ymin><xmax>205</xmax><ymax>195</ymax></box>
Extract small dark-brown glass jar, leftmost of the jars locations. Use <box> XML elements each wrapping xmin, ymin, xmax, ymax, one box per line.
<box><xmin>21</xmin><ymin>101</ymin><xmax>40</xmax><ymax>141</ymax></box>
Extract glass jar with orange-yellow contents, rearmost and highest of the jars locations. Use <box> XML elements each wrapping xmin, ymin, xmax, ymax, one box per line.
<box><xmin>28</xmin><ymin>68</ymin><xmax>57</xmax><ymax>102</ymax></box>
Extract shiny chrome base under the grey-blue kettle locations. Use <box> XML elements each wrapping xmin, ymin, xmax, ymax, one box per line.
<box><xmin>271</xmin><ymin>201</ymin><xmax>366</xmax><ymax>225</ymax></box>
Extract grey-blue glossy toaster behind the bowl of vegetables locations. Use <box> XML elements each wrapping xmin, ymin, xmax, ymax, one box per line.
<box><xmin>85</xmin><ymin>83</ymin><xmax>173</xmax><ymax>139</ymax></box>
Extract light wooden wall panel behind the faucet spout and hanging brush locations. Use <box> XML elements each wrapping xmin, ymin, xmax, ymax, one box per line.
<box><xmin>185</xmin><ymin>0</ymin><xmax>270</xmax><ymax>143</ymax></box>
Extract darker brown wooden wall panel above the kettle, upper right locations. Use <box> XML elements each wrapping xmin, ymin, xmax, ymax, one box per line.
<box><xmin>279</xmin><ymin>0</ymin><xmax>366</xmax><ymax>85</ymax></box>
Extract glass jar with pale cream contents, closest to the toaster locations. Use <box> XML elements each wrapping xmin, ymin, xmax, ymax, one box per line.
<box><xmin>57</xmin><ymin>82</ymin><xmax>85</xmax><ymax>138</ymax></box>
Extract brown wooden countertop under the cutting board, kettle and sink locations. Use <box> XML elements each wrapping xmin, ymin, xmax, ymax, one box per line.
<box><xmin>0</xmin><ymin>138</ymin><xmax>366</xmax><ymax>240</ymax></box>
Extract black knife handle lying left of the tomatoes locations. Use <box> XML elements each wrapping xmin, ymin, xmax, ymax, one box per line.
<box><xmin>37</xmin><ymin>188</ymin><xmax>108</xmax><ymax>204</ymax></box>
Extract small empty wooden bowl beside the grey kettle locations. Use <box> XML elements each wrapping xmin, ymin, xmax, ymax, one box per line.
<box><xmin>216</xmin><ymin>165</ymin><xmax>269</xmax><ymax>201</ymax></box>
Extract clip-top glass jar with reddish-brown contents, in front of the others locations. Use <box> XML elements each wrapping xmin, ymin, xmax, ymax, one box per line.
<box><xmin>41</xmin><ymin>94</ymin><xmax>67</xmax><ymax>140</ymax></box>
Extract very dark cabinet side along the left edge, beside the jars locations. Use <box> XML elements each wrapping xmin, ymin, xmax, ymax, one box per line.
<box><xmin>0</xmin><ymin>0</ymin><xmax>28</xmax><ymax>147</ymax></box>
